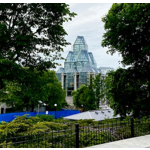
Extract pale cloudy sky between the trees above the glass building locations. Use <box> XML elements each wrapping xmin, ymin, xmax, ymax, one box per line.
<box><xmin>56</xmin><ymin>3</ymin><xmax>122</xmax><ymax>70</ymax></box>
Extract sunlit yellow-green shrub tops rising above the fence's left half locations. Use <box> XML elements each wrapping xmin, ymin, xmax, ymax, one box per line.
<box><xmin>0</xmin><ymin>115</ymin><xmax>67</xmax><ymax>138</ymax></box>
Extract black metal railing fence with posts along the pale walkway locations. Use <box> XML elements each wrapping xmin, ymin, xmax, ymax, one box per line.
<box><xmin>0</xmin><ymin>118</ymin><xmax>150</xmax><ymax>148</ymax></box>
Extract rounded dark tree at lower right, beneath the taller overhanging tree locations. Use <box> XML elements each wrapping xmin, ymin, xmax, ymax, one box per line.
<box><xmin>105</xmin><ymin>68</ymin><xmax>150</xmax><ymax>117</ymax></box>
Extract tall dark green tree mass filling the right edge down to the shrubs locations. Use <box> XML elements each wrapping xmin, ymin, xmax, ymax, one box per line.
<box><xmin>102</xmin><ymin>3</ymin><xmax>150</xmax><ymax>116</ymax></box>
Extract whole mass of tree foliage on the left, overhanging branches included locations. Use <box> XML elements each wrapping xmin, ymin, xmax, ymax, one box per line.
<box><xmin>0</xmin><ymin>3</ymin><xmax>76</xmax><ymax>111</ymax></box>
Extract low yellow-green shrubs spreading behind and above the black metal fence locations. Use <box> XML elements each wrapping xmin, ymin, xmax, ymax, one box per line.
<box><xmin>0</xmin><ymin>115</ymin><xmax>150</xmax><ymax>148</ymax></box>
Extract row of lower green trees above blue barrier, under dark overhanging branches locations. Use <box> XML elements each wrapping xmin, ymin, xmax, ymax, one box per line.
<box><xmin>0</xmin><ymin>69</ymin><xmax>67</xmax><ymax>111</ymax></box>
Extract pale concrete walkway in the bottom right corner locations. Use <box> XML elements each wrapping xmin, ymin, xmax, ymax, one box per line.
<box><xmin>86</xmin><ymin>135</ymin><xmax>150</xmax><ymax>148</ymax></box>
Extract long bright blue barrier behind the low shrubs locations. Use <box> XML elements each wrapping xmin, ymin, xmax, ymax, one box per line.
<box><xmin>0</xmin><ymin>109</ymin><xmax>81</xmax><ymax>122</ymax></box>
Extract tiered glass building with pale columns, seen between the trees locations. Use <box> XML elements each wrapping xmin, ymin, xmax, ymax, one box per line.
<box><xmin>56</xmin><ymin>36</ymin><xmax>113</xmax><ymax>103</ymax></box>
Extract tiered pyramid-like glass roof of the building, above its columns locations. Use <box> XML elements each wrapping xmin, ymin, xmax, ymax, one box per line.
<box><xmin>57</xmin><ymin>36</ymin><xmax>101</xmax><ymax>73</ymax></box>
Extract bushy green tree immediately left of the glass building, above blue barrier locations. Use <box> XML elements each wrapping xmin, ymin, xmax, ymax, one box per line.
<box><xmin>39</xmin><ymin>71</ymin><xmax>67</xmax><ymax>110</ymax></box>
